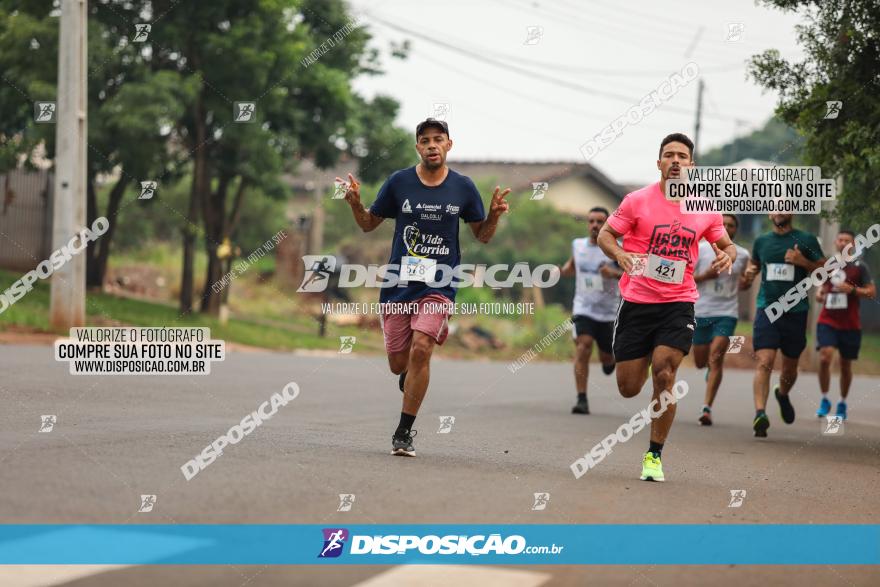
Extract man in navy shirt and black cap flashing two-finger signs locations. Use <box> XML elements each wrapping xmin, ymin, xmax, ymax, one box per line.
<box><xmin>337</xmin><ymin>118</ymin><xmax>510</xmax><ymax>456</ymax></box>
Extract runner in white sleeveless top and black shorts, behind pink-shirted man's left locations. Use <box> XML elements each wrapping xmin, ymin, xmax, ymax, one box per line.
<box><xmin>560</xmin><ymin>207</ymin><xmax>623</xmax><ymax>414</ymax></box>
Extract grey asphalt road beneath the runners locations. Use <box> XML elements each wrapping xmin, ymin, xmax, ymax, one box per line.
<box><xmin>0</xmin><ymin>345</ymin><xmax>880</xmax><ymax>587</ymax></box>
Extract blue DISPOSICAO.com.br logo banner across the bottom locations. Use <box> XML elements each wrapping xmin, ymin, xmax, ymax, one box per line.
<box><xmin>0</xmin><ymin>524</ymin><xmax>880</xmax><ymax>565</ymax></box>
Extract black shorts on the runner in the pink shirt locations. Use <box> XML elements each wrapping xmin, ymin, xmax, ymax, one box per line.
<box><xmin>612</xmin><ymin>300</ymin><xmax>696</xmax><ymax>362</ymax></box>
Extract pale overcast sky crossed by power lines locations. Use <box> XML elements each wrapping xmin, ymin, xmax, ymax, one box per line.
<box><xmin>351</xmin><ymin>0</ymin><xmax>802</xmax><ymax>183</ymax></box>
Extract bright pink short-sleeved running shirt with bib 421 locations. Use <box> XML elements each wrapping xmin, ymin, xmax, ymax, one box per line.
<box><xmin>608</xmin><ymin>182</ymin><xmax>727</xmax><ymax>304</ymax></box>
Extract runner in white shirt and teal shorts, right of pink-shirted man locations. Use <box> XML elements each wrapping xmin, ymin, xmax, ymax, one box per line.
<box><xmin>693</xmin><ymin>214</ymin><xmax>751</xmax><ymax>426</ymax></box>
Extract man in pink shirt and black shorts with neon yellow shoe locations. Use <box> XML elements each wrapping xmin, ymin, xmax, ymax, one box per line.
<box><xmin>598</xmin><ymin>133</ymin><xmax>736</xmax><ymax>481</ymax></box>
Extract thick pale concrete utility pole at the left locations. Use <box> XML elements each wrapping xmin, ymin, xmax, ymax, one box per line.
<box><xmin>49</xmin><ymin>0</ymin><xmax>88</xmax><ymax>331</ymax></box>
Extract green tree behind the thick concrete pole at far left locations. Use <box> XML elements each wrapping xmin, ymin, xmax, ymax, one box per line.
<box><xmin>0</xmin><ymin>0</ymin><xmax>192</xmax><ymax>286</ymax></box>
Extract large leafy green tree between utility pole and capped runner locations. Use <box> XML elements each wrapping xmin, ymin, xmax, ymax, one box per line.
<box><xmin>140</xmin><ymin>0</ymin><xmax>410</xmax><ymax>313</ymax></box>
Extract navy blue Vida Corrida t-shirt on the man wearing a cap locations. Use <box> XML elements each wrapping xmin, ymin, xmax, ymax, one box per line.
<box><xmin>370</xmin><ymin>167</ymin><xmax>486</xmax><ymax>303</ymax></box>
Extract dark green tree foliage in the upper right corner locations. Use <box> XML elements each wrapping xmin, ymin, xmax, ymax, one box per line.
<box><xmin>750</xmin><ymin>0</ymin><xmax>880</xmax><ymax>224</ymax></box>
